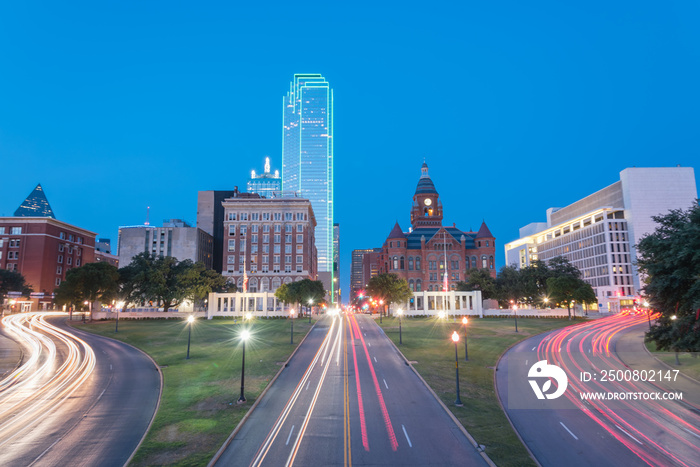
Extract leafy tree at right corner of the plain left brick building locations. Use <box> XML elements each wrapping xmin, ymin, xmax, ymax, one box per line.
<box><xmin>54</xmin><ymin>263</ymin><xmax>119</xmax><ymax>319</ymax></box>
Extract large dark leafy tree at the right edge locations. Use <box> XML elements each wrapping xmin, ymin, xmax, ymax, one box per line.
<box><xmin>637</xmin><ymin>202</ymin><xmax>700</xmax><ymax>352</ymax></box>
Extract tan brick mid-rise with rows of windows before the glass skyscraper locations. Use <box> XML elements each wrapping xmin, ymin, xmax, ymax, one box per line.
<box><xmin>222</xmin><ymin>193</ymin><xmax>317</xmax><ymax>293</ymax></box>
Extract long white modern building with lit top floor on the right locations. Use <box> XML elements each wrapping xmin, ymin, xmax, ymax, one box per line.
<box><xmin>505</xmin><ymin>167</ymin><xmax>697</xmax><ymax>311</ymax></box>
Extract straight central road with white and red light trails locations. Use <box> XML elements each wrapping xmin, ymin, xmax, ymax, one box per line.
<box><xmin>216</xmin><ymin>315</ymin><xmax>486</xmax><ymax>466</ymax></box>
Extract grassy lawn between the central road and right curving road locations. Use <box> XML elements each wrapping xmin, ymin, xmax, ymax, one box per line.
<box><xmin>377</xmin><ymin>317</ymin><xmax>580</xmax><ymax>467</ymax></box>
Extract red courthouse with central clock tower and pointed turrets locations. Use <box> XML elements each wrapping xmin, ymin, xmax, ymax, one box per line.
<box><xmin>379</xmin><ymin>163</ymin><xmax>496</xmax><ymax>292</ymax></box>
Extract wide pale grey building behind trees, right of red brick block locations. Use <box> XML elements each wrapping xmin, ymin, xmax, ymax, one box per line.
<box><xmin>118</xmin><ymin>219</ymin><xmax>214</xmax><ymax>269</ymax></box>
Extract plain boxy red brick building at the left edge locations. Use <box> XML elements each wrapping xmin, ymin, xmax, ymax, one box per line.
<box><xmin>0</xmin><ymin>217</ymin><xmax>97</xmax><ymax>309</ymax></box>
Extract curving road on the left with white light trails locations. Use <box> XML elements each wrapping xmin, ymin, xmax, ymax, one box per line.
<box><xmin>0</xmin><ymin>313</ymin><xmax>161</xmax><ymax>466</ymax></box>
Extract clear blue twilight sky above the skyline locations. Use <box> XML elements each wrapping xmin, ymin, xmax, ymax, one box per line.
<box><xmin>0</xmin><ymin>1</ymin><xmax>700</xmax><ymax>304</ymax></box>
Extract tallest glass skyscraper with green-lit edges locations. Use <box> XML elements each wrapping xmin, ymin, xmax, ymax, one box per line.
<box><xmin>282</xmin><ymin>74</ymin><xmax>335</xmax><ymax>302</ymax></box>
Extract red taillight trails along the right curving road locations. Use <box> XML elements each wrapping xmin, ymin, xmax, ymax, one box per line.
<box><xmin>537</xmin><ymin>312</ymin><xmax>700</xmax><ymax>467</ymax></box>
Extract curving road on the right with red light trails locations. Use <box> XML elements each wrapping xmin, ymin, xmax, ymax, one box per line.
<box><xmin>497</xmin><ymin>314</ymin><xmax>700</xmax><ymax>466</ymax></box>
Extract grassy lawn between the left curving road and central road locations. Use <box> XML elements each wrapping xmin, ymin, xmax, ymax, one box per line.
<box><xmin>73</xmin><ymin>319</ymin><xmax>311</xmax><ymax>466</ymax></box>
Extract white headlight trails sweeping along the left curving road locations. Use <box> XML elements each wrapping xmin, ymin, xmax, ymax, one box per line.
<box><xmin>0</xmin><ymin>312</ymin><xmax>95</xmax><ymax>446</ymax></box>
